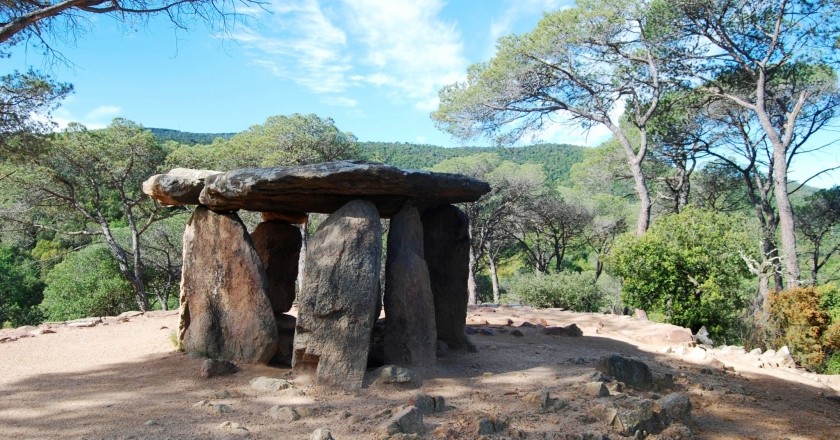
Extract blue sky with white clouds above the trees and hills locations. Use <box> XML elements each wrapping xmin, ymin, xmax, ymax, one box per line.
<box><xmin>0</xmin><ymin>0</ymin><xmax>840</xmax><ymax>186</ymax></box>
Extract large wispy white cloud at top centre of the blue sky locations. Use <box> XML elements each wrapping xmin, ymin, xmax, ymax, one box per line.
<box><xmin>232</xmin><ymin>0</ymin><xmax>467</xmax><ymax>111</ymax></box>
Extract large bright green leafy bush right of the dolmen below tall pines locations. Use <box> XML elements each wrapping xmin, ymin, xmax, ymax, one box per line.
<box><xmin>608</xmin><ymin>208</ymin><xmax>752</xmax><ymax>338</ymax></box>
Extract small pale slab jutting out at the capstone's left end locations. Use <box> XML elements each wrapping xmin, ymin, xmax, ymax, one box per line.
<box><xmin>143</xmin><ymin>168</ymin><xmax>219</xmax><ymax>205</ymax></box>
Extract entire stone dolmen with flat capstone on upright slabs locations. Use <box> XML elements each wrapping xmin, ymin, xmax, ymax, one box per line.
<box><xmin>143</xmin><ymin>161</ymin><xmax>490</xmax><ymax>389</ymax></box>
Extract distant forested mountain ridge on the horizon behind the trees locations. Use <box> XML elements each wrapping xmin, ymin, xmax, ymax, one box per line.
<box><xmin>148</xmin><ymin>128</ymin><xmax>586</xmax><ymax>182</ymax></box>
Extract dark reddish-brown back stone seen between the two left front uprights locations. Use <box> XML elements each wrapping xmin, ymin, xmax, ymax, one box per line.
<box><xmin>251</xmin><ymin>220</ymin><xmax>302</xmax><ymax>315</ymax></box>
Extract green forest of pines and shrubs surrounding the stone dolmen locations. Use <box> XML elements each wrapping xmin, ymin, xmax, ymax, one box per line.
<box><xmin>0</xmin><ymin>0</ymin><xmax>840</xmax><ymax>373</ymax></box>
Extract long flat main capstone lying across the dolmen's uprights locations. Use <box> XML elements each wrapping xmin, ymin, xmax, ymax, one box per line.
<box><xmin>200</xmin><ymin>161</ymin><xmax>490</xmax><ymax>217</ymax></box>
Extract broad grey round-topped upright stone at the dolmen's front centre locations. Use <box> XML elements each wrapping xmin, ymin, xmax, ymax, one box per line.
<box><xmin>292</xmin><ymin>200</ymin><xmax>382</xmax><ymax>389</ymax></box>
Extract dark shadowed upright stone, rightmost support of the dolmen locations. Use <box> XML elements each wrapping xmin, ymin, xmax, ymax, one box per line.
<box><xmin>423</xmin><ymin>205</ymin><xmax>471</xmax><ymax>350</ymax></box>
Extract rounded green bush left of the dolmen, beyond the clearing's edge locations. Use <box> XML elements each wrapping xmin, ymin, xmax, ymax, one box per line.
<box><xmin>41</xmin><ymin>244</ymin><xmax>136</xmax><ymax>321</ymax></box>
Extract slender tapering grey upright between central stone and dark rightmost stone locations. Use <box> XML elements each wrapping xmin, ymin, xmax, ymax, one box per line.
<box><xmin>384</xmin><ymin>205</ymin><xmax>437</xmax><ymax>366</ymax></box>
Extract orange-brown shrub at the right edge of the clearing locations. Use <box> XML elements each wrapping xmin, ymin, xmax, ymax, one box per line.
<box><xmin>770</xmin><ymin>287</ymin><xmax>840</xmax><ymax>371</ymax></box>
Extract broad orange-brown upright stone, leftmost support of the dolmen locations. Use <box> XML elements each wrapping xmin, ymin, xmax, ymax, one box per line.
<box><xmin>180</xmin><ymin>207</ymin><xmax>277</xmax><ymax>363</ymax></box>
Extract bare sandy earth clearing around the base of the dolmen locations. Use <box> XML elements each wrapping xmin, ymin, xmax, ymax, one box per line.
<box><xmin>0</xmin><ymin>307</ymin><xmax>840</xmax><ymax>440</ymax></box>
